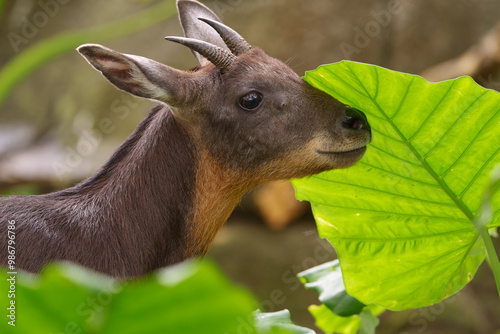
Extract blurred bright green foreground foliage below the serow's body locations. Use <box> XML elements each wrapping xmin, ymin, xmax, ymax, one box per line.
<box><xmin>0</xmin><ymin>261</ymin><xmax>258</xmax><ymax>334</ymax></box>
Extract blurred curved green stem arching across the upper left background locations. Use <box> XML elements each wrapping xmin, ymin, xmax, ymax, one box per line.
<box><xmin>0</xmin><ymin>0</ymin><xmax>177</xmax><ymax>105</ymax></box>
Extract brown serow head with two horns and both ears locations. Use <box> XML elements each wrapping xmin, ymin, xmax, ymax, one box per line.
<box><xmin>78</xmin><ymin>0</ymin><xmax>371</xmax><ymax>180</ymax></box>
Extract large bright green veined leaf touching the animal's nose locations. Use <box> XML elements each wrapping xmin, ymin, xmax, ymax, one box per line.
<box><xmin>294</xmin><ymin>61</ymin><xmax>500</xmax><ymax>310</ymax></box>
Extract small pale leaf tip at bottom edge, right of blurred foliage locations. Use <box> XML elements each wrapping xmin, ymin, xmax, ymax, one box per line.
<box><xmin>254</xmin><ymin>310</ymin><xmax>316</xmax><ymax>334</ymax></box>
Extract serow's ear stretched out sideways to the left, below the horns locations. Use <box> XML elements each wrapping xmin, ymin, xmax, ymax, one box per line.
<box><xmin>77</xmin><ymin>44</ymin><xmax>185</xmax><ymax>105</ymax></box>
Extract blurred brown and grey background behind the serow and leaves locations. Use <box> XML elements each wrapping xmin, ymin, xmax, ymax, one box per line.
<box><xmin>0</xmin><ymin>0</ymin><xmax>500</xmax><ymax>333</ymax></box>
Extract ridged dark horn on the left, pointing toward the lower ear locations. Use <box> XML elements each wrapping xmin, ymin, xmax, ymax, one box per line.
<box><xmin>165</xmin><ymin>36</ymin><xmax>236</xmax><ymax>72</ymax></box>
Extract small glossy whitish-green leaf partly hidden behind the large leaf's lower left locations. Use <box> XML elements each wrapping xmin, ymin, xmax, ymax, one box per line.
<box><xmin>297</xmin><ymin>260</ymin><xmax>365</xmax><ymax>317</ymax></box>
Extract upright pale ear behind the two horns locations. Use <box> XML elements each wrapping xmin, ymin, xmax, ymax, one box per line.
<box><xmin>177</xmin><ymin>0</ymin><xmax>229</xmax><ymax>66</ymax></box>
